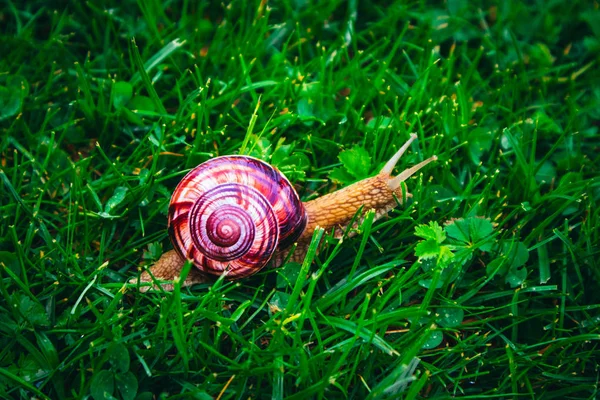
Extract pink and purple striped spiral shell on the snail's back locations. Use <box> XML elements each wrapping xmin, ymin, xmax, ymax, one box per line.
<box><xmin>169</xmin><ymin>156</ymin><xmax>306</xmax><ymax>279</ymax></box>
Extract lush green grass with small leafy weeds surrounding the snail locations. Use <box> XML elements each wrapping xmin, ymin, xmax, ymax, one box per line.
<box><xmin>0</xmin><ymin>0</ymin><xmax>600</xmax><ymax>399</ymax></box>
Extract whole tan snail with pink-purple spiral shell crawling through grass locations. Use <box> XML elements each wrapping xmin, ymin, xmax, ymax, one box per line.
<box><xmin>130</xmin><ymin>134</ymin><xmax>437</xmax><ymax>291</ymax></box>
